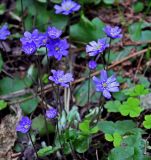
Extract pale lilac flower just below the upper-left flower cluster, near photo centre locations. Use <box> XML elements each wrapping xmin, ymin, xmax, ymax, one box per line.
<box><xmin>49</xmin><ymin>70</ymin><xmax>74</xmax><ymax>87</ymax></box>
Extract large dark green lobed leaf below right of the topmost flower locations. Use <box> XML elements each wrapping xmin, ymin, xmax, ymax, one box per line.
<box><xmin>70</xmin><ymin>16</ymin><xmax>105</xmax><ymax>43</ymax></box>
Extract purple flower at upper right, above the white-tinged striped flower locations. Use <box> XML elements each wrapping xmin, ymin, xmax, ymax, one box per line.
<box><xmin>103</xmin><ymin>26</ymin><xmax>123</xmax><ymax>39</ymax></box>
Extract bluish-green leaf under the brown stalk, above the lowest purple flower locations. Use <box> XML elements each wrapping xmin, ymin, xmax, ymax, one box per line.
<box><xmin>20</xmin><ymin>98</ymin><xmax>39</xmax><ymax>114</ymax></box>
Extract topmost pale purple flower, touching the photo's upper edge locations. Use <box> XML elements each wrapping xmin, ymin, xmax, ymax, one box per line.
<box><xmin>54</xmin><ymin>0</ymin><xmax>81</xmax><ymax>15</ymax></box>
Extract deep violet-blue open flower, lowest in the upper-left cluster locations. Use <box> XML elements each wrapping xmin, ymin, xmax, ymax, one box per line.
<box><xmin>46</xmin><ymin>39</ymin><xmax>69</xmax><ymax>61</ymax></box>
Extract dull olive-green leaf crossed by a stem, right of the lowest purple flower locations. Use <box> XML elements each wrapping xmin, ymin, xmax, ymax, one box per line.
<box><xmin>32</xmin><ymin>115</ymin><xmax>54</xmax><ymax>136</ymax></box>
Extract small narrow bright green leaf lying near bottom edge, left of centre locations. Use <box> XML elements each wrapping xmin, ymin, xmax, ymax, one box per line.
<box><xmin>37</xmin><ymin>146</ymin><xmax>58</xmax><ymax>157</ymax></box>
